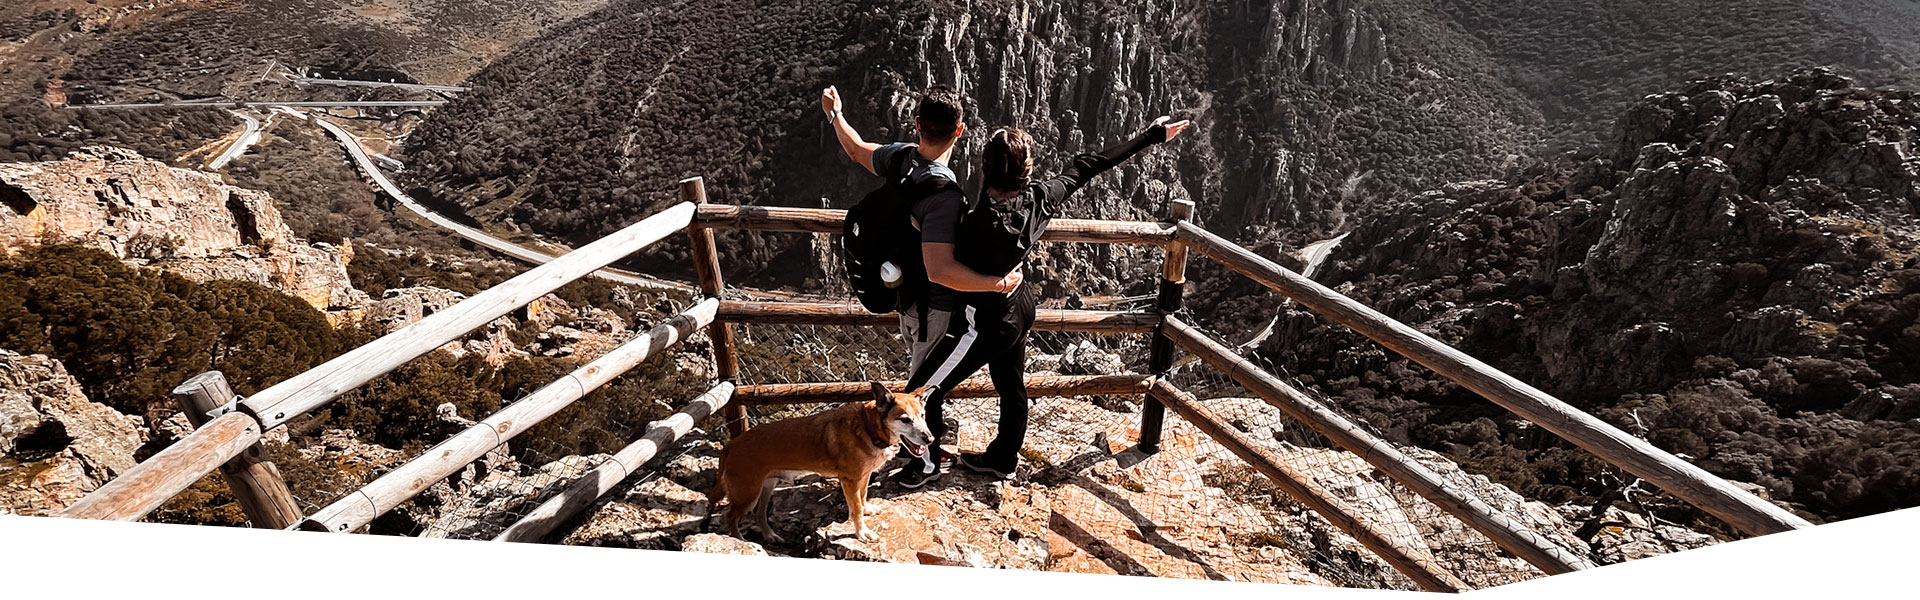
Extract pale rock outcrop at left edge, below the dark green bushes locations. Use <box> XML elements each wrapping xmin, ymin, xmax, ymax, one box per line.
<box><xmin>0</xmin><ymin>350</ymin><xmax>146</xmax><ymax>515</ymax></box>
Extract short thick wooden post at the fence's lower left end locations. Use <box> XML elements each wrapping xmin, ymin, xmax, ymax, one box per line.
<box><xmin>173</xmin><ymin>371</ymin><xmax>301</xmax><ymax>529</ymax></box>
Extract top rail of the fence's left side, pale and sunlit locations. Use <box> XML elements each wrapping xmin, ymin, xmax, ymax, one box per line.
<box><xmin>242</xmin><ymin>204</ymin><xmax>693</xmax><ymax>429</ymax></box>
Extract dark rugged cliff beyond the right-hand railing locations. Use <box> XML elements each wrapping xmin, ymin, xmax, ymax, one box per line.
<box><xmin>1244</xmin><ymin>71</ymin><xmax>1920</xmax><ymax>519</ymax></box>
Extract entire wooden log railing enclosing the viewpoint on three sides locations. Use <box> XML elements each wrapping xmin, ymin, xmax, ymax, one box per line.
<box><xmin>61</xmin><ymin>179</ymin><xmax>1811</xmax><ymax>590</ymax></box>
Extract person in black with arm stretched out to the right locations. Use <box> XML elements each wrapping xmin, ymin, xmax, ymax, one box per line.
<box><xmin>893</xmin><ymin>117</ymin><xmax>1192</xmax><ymax>488</ymax></box>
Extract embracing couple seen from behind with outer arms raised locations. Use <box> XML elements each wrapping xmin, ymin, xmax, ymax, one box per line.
<box><xmin>820</xmin><ymin>85</ymin><xmax>1190</xmax><ymax>488</ymax></box>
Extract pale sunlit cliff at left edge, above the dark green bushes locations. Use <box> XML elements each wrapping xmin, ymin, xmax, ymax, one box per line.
<box><xmin>0</xmin><ymin>148</ymin><xmax>367</xmax><ymax>323</ymax></box>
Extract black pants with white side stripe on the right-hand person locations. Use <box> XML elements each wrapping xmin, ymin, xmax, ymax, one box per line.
<box><xmin>906</xmin><ymin>285</ymin><xmax>1035</xmax><ymax>471</ymax></box>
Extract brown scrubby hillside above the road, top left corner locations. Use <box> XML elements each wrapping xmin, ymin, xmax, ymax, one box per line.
<box><xmin>0</xmin><ymin>0</ymin><xmax>603</xmax><ymax>162</ymax></box>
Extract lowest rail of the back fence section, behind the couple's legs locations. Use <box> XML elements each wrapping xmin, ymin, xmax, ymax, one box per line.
<box><xmin>733</xmin><ymin>375</ymin><xmax>1150</xmax><ymax>406</ymax></box>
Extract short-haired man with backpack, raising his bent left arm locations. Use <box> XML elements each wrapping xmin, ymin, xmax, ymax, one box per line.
<box><xmin>820</xmin><ymin>85</ymin><xmax>1021</xmax><ymax>488</ymax></box>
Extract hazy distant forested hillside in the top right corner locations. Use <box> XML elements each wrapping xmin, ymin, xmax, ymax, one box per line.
<box><xmin>1438</xmin><ymin>0</ymin><xmax>1910</xmax><ymax>150</ymax></box>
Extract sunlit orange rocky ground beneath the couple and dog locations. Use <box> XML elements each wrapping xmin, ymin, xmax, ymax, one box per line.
<box><xmin>545</xmin><ymin>388</ymin><xmax>1713</xmax><ymax>588</ymax></box>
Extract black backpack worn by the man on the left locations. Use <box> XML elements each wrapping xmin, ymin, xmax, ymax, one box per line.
<box><xmin>841</xmin><ymin>148</ymin><xmax>960</xmax><ymax>313</ymax></box>
